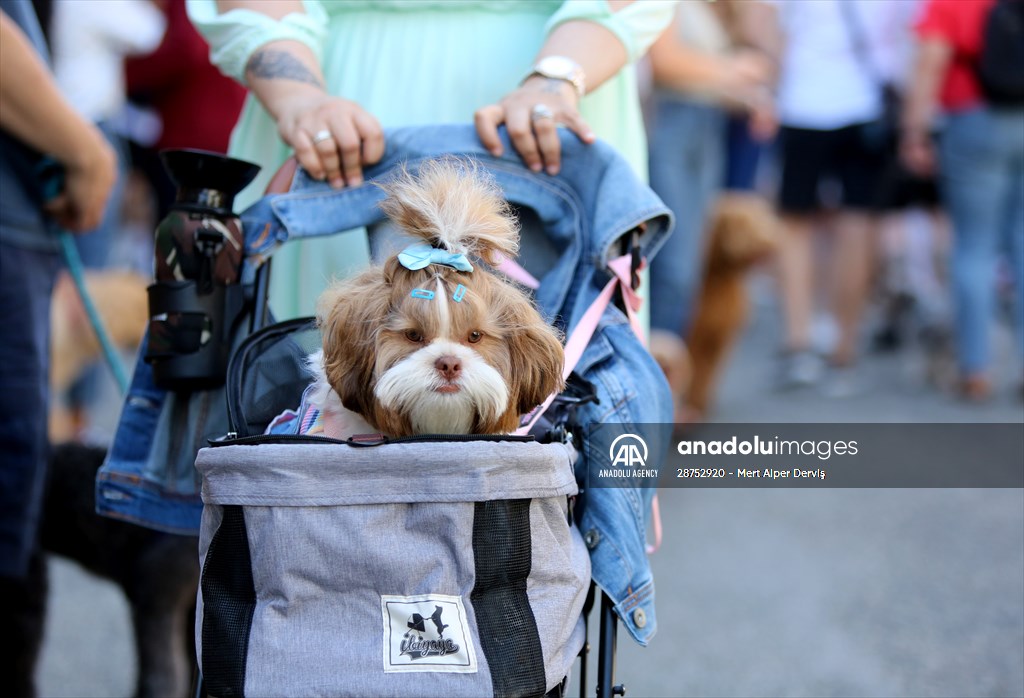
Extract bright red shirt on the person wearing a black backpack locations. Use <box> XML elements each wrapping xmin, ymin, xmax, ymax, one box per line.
<box><xmin>915</xmin><ymin>0</ymin><xmax>995</xmax><ymax>112</ymax></box>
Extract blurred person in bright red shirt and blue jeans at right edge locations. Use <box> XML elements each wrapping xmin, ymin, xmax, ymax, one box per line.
<box><xmin>901</xmin><ymin>0</ymin><xmax>1024</xmax><ymax>400</ymax></box>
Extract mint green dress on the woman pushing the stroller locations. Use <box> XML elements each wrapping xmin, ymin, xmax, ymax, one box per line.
<box><xmin>187</xmin><ymin>0</ymin><xmax>675</xmax><ymax>319</ymax></box>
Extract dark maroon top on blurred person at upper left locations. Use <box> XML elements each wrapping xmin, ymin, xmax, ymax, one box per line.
<box><xmin>125</xmin><ymin>0</ymin><xmax>246</xmax><ymax>152</ymax></box>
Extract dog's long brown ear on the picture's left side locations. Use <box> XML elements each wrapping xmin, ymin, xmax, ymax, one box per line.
<box><xmin>316</xmin><ymin>267</ymin><xmax>390</xmax><ymax>418</ymax></box>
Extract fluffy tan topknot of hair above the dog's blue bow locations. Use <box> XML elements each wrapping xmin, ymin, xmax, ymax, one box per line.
<box><xmin>380</xmin><ymin>158</ymin><xmax>519</xmax><ymax>265</ymax></box>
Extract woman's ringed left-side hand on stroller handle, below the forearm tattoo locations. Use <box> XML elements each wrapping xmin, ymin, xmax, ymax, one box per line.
<box><xmin>278</xmin><ymin>93</ymin><xmax>384</xmax><ymax>189</ymax></box>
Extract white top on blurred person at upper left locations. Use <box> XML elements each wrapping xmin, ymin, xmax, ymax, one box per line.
<box><xmin>50</xmin><ymin>0</ymin><xmax>167</xmax><ymax>122</ymax></box>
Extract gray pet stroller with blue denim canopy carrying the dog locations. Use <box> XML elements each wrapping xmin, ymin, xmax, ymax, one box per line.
<box><xmin>121</xmin><ymin>126</ymin><xmax>672</xmax><ymax>696</ymax></box>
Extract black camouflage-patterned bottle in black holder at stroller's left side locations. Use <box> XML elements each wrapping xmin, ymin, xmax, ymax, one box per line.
<box><xmin>145</xmin><ymin>149</ymin><xmax>260</xmax><ymax>391</ymax></box>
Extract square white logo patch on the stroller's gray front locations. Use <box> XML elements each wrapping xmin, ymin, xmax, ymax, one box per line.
<box><xmin>381</xmin><ymin>594</ymin><xmax>476</xmax><ymax>673</ymax></box>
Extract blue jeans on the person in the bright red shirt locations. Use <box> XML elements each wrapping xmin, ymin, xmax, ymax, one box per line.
<box><xmin>940</xmin><ymin>108</ymin><xmax>1024</xmax><ymax>375</ymax></box>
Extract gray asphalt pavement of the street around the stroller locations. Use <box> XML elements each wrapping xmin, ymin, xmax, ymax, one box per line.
<box><xmin>38</xmin><ymin>272</ymin><xmax>1024</xmax><ymax>698</ymax></box>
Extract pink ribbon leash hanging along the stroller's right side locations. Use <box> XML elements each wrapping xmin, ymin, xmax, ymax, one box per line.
<box><xmin>497</xmin><ymin>255</ymin><xmax>663</xmax><ymax>555</ymax></box>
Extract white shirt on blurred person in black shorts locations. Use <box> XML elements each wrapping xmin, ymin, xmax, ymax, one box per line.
<box><xmin>772</xmin><ymin>0</ymin><xmax>909</xmax><ymax>130</ymax></box>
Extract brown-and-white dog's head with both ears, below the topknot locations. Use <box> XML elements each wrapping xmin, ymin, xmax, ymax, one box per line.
<box><xmin>319</xmin><ymin>258</ymin><xmax>564</xmax><ymax>437</ymax></box>
